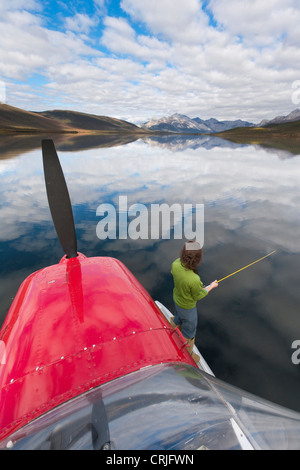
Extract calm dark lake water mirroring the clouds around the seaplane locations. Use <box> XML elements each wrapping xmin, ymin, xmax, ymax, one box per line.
<box><xmin>0</xmin><ymin>132</ymin><xmax>300</xmax><ymax>411</ymax></box>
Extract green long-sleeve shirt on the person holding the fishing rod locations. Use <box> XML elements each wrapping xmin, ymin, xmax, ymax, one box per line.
<box><xmin>171</xmin><ymin>258</ymin><xmax>208</xmax><ymax>309</ymax></box>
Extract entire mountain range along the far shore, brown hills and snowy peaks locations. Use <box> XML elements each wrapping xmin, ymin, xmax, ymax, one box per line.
<box><xmin>0</xmin><ymin>103</ymin><xmax>300</xmax><ymax>135</ymax></box>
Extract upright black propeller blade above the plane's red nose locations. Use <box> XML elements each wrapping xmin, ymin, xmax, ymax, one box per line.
<box><xmin>42</xmin><ymin>139</ymin><xmax>78</xmax><ymax>258</ymax></box>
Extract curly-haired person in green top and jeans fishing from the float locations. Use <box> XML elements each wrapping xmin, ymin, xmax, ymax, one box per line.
<box><xmin>171</xmin><ymin>241</ymin><xmax>218</xmax><ymax>362</ymax></box>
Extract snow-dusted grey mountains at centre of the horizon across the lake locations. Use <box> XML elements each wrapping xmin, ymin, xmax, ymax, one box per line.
<box><xmin>141</xmin><ymin>113</ymin><xmax>253</xmax><ymax>134</ymax></box>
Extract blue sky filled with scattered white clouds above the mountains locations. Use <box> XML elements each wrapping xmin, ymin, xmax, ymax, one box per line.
<box><xmin>0</xmin><ymin>0</ymin><xmax>300</xmax><ymax>123</ymax></box>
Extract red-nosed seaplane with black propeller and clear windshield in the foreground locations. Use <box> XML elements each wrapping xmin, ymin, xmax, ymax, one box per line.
<box><xmin>0</xmin><ymin>139</ymin><xmax>300</xmax><ymax>452</ymax></box>
